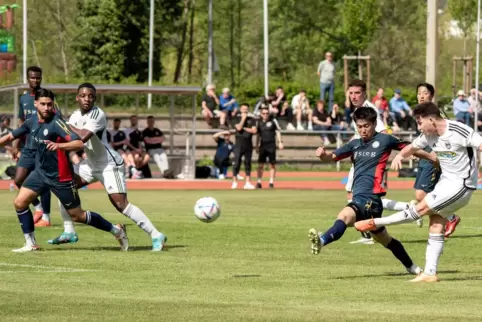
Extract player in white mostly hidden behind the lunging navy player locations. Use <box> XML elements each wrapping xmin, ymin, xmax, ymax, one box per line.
<box><xmin>345</xmin><ymin>79</ymin><xmax>387</xmax><ymax>245</ymax></box>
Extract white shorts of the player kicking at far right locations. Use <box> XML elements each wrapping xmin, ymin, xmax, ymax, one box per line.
<box><xmin>424</xmin><ymin>180</ymin><xmax>474</xmax><ymax>217</ymax></box>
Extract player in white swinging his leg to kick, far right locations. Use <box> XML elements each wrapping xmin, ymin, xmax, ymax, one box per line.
<box><xmin>355</xmin><ymin>103</ymin><xmax>482</xmax><ymax>282</ymax></box>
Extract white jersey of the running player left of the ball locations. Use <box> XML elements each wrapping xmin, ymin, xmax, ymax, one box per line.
<box><xmin>69</xmin><ymin>106</ymin><xmax>124</xmax><ymax>170</ymax></box>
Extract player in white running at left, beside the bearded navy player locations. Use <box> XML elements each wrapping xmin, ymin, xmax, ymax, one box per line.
<box><xmin>49</xmin><ymin>83</ymin><xmax>166</xmax><ymax>251</ymax></box>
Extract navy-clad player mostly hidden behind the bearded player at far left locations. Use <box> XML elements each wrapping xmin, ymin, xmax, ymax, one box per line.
<box><xmin>13</xmin><ymin>66</ymin><xmax>51</xmax><ymax>227</ymax></box>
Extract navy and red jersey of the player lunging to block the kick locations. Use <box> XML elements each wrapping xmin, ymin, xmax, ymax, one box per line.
<box><xmin>333</xmin><ymin>133</ymin><xmax>409</xmax><ymax>196</ymax></box>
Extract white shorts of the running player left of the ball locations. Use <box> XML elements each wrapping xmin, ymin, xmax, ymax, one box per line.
<box><xmin>75</xmin><ymin>159</ymin><xmax>127</xmax><ymax>194</ymax></box>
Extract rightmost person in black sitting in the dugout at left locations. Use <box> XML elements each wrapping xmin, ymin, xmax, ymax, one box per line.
<box><xmin>142</xmin><ymin>115</ymin><xmax>169</xmax><ymax>176</ymax></box>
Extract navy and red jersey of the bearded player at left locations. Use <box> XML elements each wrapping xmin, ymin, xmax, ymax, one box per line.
<box><xmin>12</xmin><ymin>114</ymin><xmax>80</xmax><ymax>182</ymax></box>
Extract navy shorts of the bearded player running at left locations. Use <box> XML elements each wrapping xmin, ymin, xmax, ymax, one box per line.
<box><xmin>22</xmin><ymin>170</ymin><xmax>80</xmax><ymax>209</ymax></box>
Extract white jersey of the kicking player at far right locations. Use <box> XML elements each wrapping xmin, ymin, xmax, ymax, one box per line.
<box><xmin>412</xmin><ymin>120</ymin><xmax>482</xmax><ymax>189</ymax></box>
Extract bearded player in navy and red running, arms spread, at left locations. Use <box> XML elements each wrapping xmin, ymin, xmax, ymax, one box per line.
<box><xmin>0</xmin><ymin>88</ymin><xmax>128</xmax><ymax>253</ymax></box>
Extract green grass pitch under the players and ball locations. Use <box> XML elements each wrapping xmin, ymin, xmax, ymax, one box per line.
<box><xmin>0</xmin><ymin>190</ymin><xmax>482</xmax><ymax>321</ymax></box>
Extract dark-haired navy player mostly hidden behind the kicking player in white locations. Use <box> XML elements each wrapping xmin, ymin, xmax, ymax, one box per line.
<box><xmin>383</xmin><ymin>83</ymin><xmax>460</xmax><ymax>237</ymax></box>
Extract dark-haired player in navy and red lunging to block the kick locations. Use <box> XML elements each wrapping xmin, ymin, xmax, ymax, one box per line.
<box><xmin>309</xmin><ymin>108</ymin><xmax>430</xmax><ymax>274</ymax></box>
